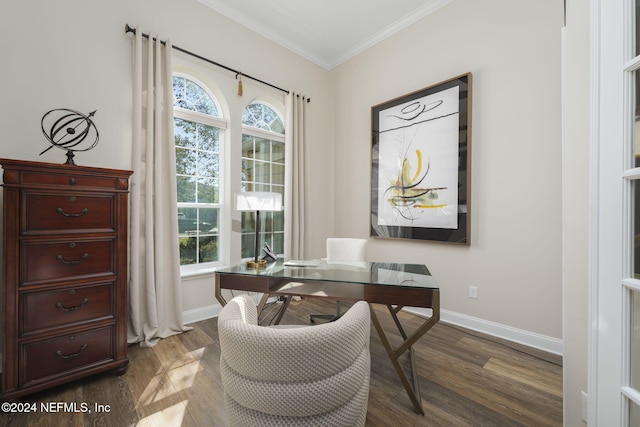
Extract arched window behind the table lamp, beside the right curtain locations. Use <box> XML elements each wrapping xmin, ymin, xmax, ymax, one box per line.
<box><xmin>241</xmin><ymin>102</ymin><xmax>285</xmax><ymax>258</ymax></box>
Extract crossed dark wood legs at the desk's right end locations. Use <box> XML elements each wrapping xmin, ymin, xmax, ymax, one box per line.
<box><xmin>369</xmin><ymin>292</ymin><xmax>440</xmax><ymax>415</ymax></box>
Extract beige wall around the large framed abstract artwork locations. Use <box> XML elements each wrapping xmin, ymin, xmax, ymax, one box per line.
<box><xmin>332</xmin><ymin>0</ymin><xmax>563</xmax><ymax>338</ymax></box>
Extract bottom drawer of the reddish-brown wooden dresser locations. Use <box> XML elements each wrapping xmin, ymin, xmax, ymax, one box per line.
<box><xmin>20</xmin><ymin>326</ymin><xmax>114</xmax><ymax>386</ymax></box>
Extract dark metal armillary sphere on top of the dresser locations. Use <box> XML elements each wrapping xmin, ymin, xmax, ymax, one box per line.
<box><xmin>40</xmin><ymin>108</ymin><xmax>100</xmax><ymax>165</ymax></box>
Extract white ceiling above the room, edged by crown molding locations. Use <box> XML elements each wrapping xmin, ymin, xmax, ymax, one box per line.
<box><xmin>198</xmin><ymin>0</ymin><xmax>452</xmax><ymax>70</ymax></box>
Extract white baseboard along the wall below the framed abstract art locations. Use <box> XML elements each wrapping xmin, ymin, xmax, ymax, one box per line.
<box><xmin>405</xmin><ymin>307</ymin><xmax>563</xmax><ymax>356</ymax></box>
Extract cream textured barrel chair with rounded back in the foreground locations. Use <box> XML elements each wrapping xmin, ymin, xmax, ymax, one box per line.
<box><xmin>218</xmin><ymin>295</ymin><xmax>371</xmax><ymax>426</ymax></box>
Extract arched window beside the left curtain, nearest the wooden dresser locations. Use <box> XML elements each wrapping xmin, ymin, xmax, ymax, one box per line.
<box><xmin>173</xmin><ymin>75</ymin><xmax>226</xmax><ymax>267</ymax></box>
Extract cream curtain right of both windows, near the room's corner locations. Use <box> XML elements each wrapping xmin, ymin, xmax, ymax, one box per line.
<box><xmin>284</xmin><ymin>91</ymin><xmax>307</xmax><ymax>259</ymax></box>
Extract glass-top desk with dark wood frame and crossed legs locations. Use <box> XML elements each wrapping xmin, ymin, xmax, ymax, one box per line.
<box><xmin>215</xmin><ymin>260</ymin><xmax>440</xmax><ymax>414</ymax></box>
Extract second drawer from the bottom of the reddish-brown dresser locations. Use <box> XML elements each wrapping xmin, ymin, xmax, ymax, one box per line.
<box><xmin>20</xmin><ymin>282</ymin><xmax>114</xmax><ymax>337</ymax></box>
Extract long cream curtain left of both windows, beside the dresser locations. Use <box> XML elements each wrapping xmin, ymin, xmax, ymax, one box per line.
<box><xmin>128</xmin><ymin>30</ymin><xmax>189</xmax><ymax>346</ymax></box>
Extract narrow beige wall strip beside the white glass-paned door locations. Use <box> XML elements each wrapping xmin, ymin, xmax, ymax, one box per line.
<box><xmin>562</xmin><ymin>0</ymin><xmax>590</xmax><ymax>427</ymax></box>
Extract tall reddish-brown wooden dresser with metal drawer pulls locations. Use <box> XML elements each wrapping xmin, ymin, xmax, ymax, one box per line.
<box><xmin>0</xmin><ymin>159</ymin><xmax>131</xmax><ymax>400</ymax></box>
